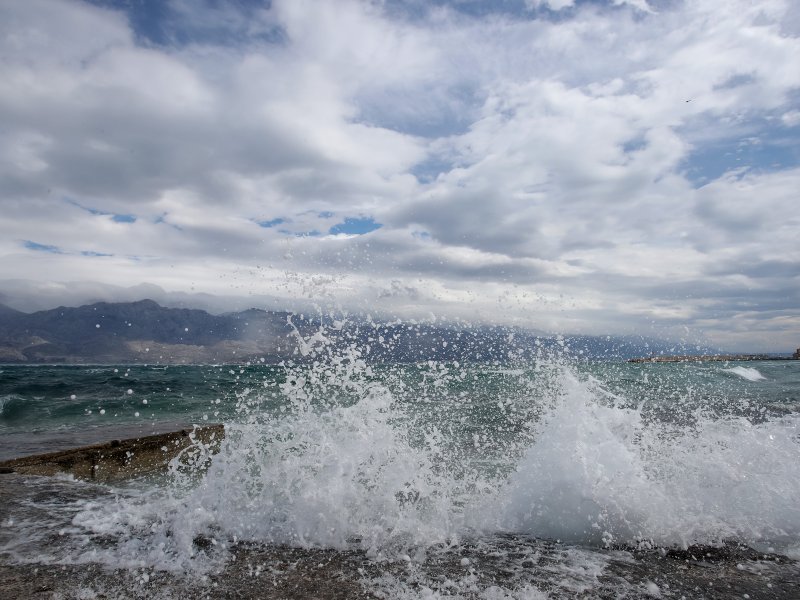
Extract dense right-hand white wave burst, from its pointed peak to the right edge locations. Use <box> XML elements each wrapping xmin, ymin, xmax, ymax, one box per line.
<box><xmin>494</xmin><ymin>370</ymin><xmax>800</xmax><ymax>548</ymax></box>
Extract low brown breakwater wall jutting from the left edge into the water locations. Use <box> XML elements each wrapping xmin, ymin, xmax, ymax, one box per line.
<box><xmin>0</xmin><ymin>425</ymin><xmax>225</xmax><ymax>482</ymax></box>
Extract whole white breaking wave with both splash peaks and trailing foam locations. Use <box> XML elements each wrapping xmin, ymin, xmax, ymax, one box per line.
<box><xmin>69</xmin><ymin>357</ymin><xmax>800</xmax><ymax>569</ymax></box>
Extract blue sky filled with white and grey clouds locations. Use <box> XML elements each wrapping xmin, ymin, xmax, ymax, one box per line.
<box><xmin>0</xmin><ymin>0</ymin><xmax>800</xmax><ymax>352</ymax></box>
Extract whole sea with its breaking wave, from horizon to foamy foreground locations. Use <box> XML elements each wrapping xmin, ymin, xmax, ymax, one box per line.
<box><xmin>0</xmin><ymin>342</ymin><xmax>800</xmax><ymax>600</ymax></box>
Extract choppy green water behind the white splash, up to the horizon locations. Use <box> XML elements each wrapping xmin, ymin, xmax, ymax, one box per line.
<box><xmin>0</xmin><ymin>361</ymin><xmax>800</xmax><ymax>458</ymax></box>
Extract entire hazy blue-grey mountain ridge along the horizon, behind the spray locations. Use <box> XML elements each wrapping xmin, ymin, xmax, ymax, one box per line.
<box><xmin>0</xmin><ymin>300</ymin><xmax>688</xmax><ymax>364</ymax></box>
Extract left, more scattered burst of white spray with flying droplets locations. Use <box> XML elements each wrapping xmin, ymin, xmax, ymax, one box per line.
<box><xmin>148</xmin><ymin>336</ymin><xmax>510</xmax><ymax>557</ymax></box>
